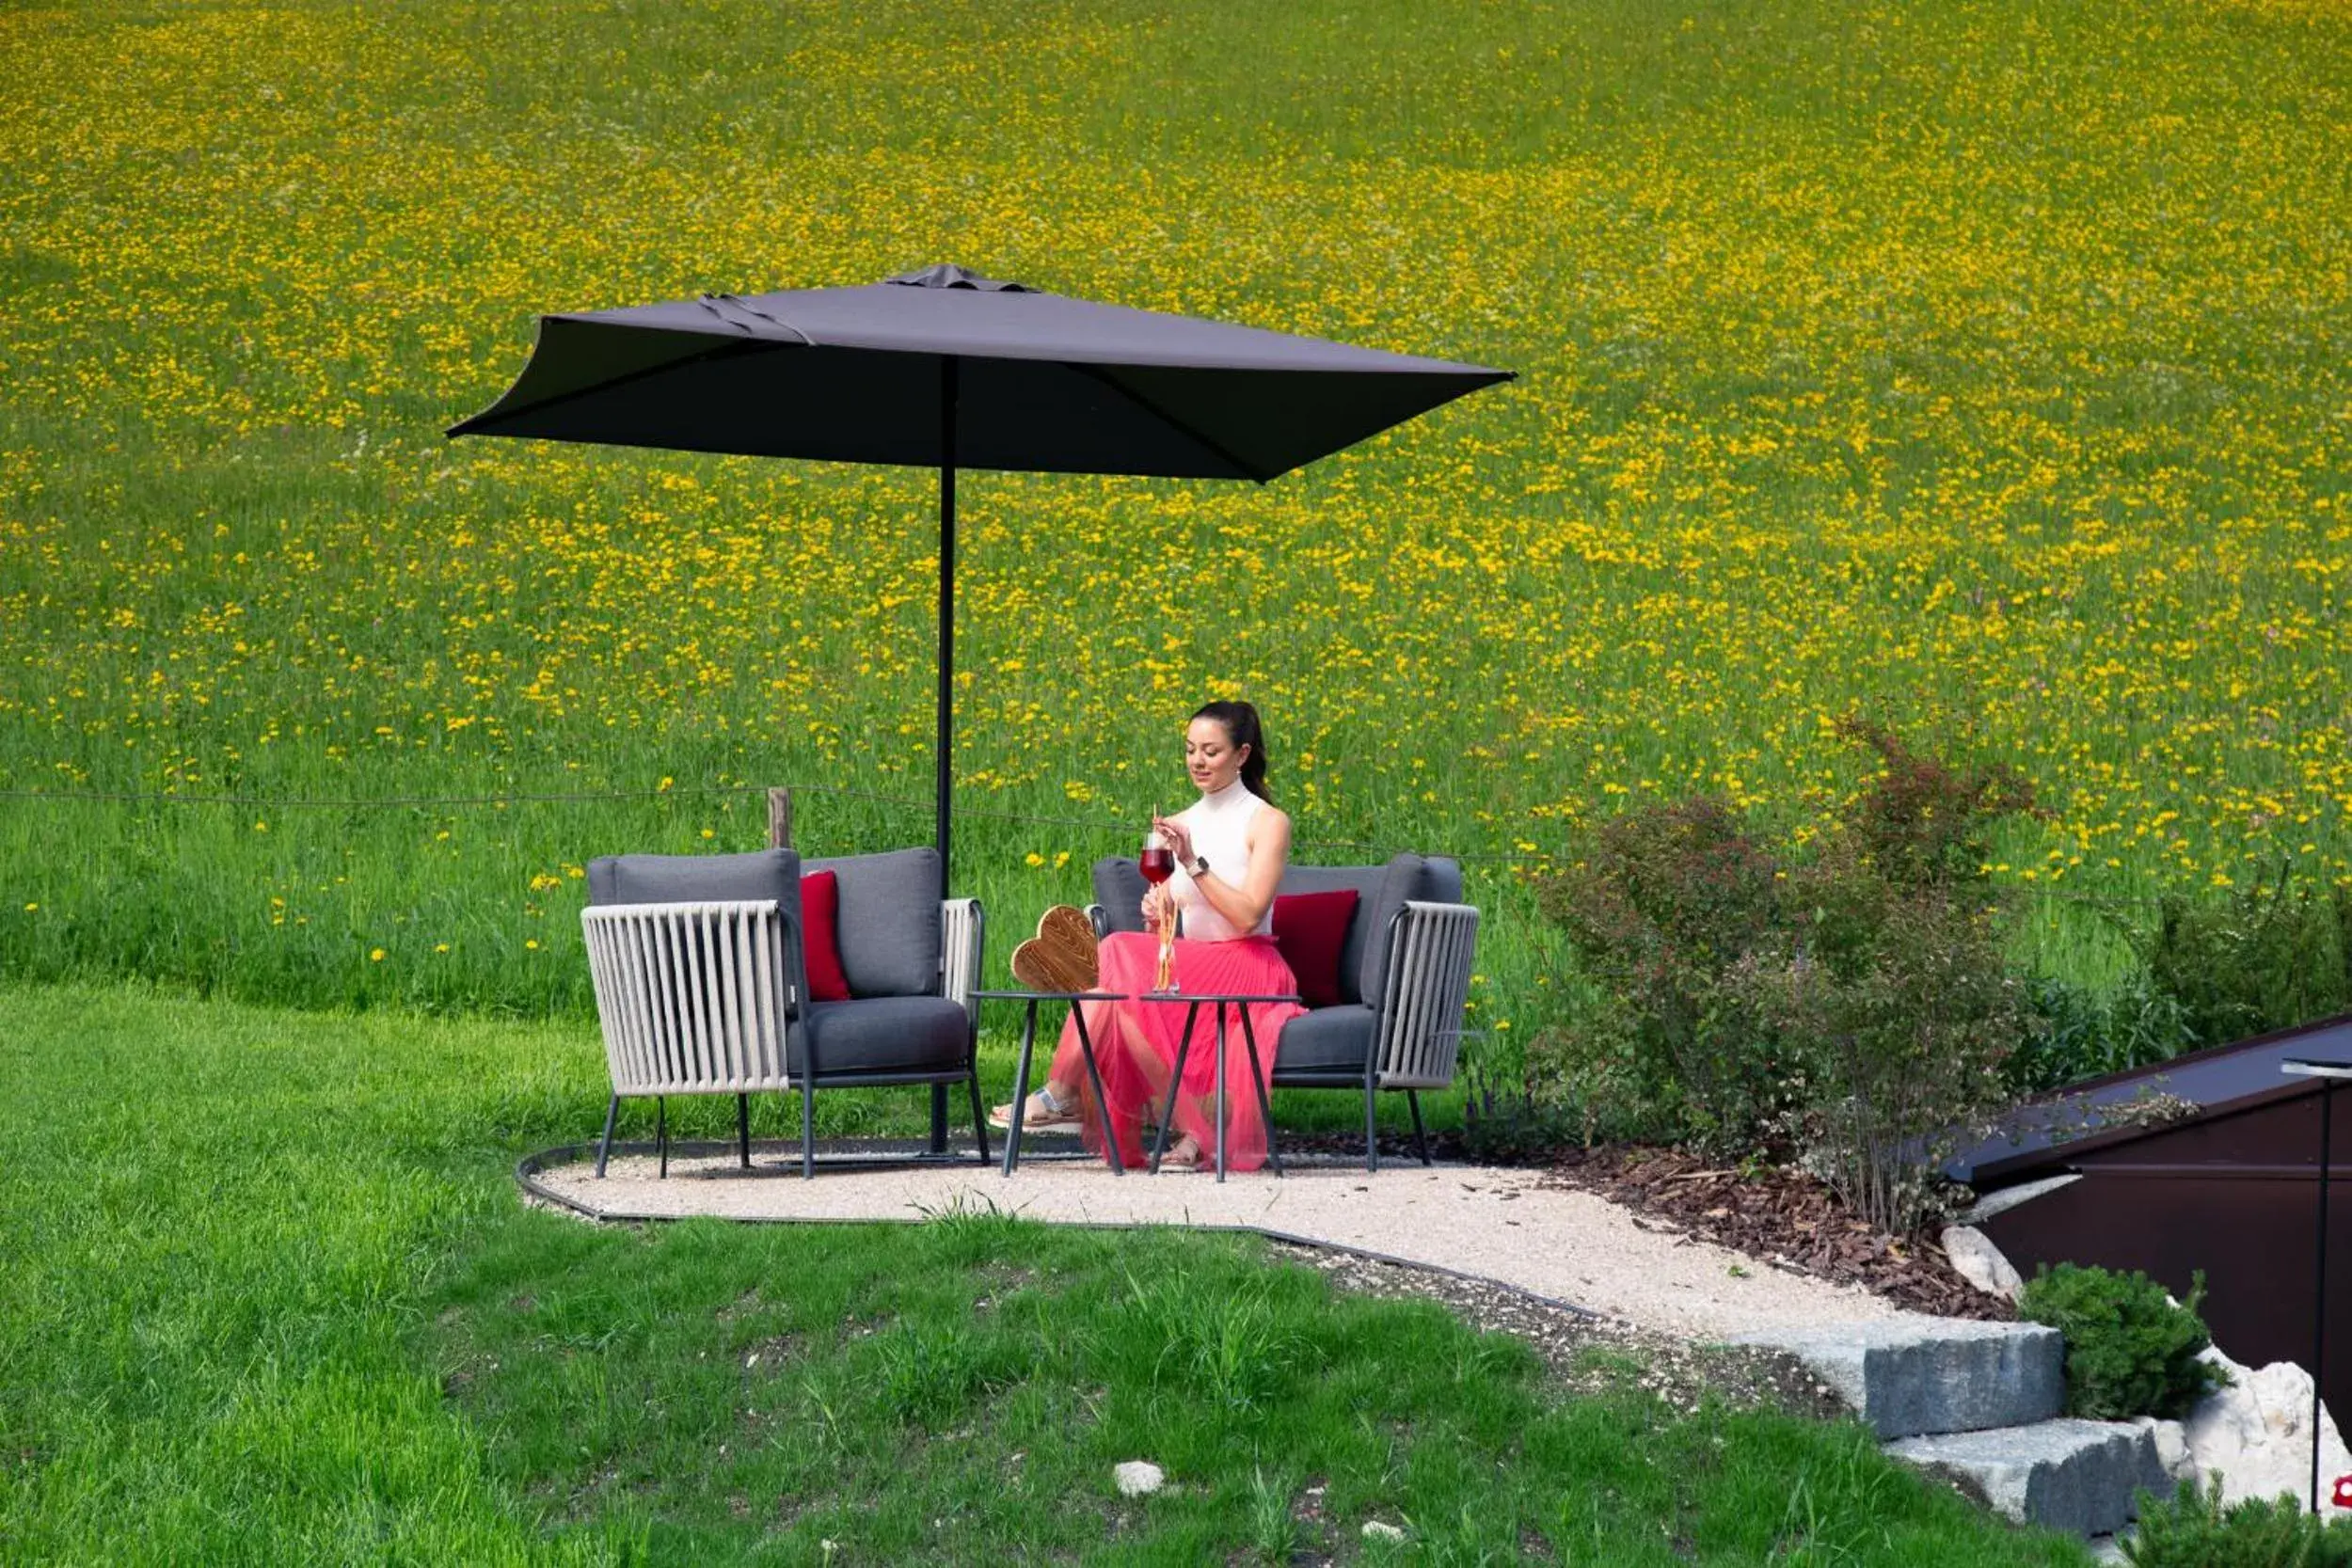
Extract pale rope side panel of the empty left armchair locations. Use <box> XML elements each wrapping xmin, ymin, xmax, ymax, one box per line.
<box><xmin>581</xmin><ymin>900</ymin><xmax>795</xmax><ymax>1096</ymax></box>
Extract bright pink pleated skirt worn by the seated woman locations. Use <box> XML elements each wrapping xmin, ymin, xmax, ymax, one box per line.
<box><xmin>1054</xmin><ymin>931</ymin><xmax>1306</xmax><ymax>1171</ymax></box>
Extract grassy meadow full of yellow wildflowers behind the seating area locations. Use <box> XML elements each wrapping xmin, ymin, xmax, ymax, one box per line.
<box><xmin>0</xmin><ymin>0</ymin><xmax>2352</xmax><ymax>1030</ymax></box>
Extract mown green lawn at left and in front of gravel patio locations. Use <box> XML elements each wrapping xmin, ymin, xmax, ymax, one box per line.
<box><xmin>0</xmin><ymin>988</ymin><xmax>2087</xmax><ymax>1568</ymax></box>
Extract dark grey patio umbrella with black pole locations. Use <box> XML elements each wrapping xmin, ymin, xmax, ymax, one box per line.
<box><xmin>450</xmin><ymin>265</ymin><xmax>1513</xmax><ymax>895</ymax></box>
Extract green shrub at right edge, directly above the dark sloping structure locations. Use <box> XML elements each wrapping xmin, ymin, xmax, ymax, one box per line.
<box><xmin>2145</xmin><ymin>861</ymin><xmax>2352</xmax><ymax>1046</ymax></box>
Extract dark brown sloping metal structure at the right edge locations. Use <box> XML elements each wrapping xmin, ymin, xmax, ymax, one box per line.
<box><xmin>1946</xmin><ymin>1013</ymin><xmax>2352</xmax><ymax>1425</ymax></box>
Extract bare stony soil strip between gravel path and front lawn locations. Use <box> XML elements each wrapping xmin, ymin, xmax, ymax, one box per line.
<box><xmin>1270</xmin><ymin>1242</ymin><xmax>1847</xmax><ymax>1418</ymax></box>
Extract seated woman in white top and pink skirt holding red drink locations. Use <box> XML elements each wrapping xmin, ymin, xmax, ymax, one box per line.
<box><xmin>993</xmin><ymin>703</ymin><xmax>1306</xmax><ymax>1171</ymax></box>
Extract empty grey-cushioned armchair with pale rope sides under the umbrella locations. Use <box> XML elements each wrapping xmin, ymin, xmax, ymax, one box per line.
<box><xmin>581</xmin><ymin>848</ymin><xmax>988</xmax><ymax>1176</ymax></box>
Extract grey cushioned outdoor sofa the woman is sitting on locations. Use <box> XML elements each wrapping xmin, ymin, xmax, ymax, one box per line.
<box><xmin>1087</xmin><ymin>853</ymin><xmax>1477</xmax><ymax>1171</ymax></box>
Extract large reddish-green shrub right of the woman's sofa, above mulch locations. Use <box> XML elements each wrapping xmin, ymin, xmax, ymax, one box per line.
<box><xmin>1538</xmin><ymin>720</ymin><xmax>2030</xmax><ymax>1232</ymax></box>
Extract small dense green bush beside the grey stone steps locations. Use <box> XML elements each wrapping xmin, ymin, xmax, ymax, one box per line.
<box><xmin>2018</xmin><ymin>1262</ymin><xmax>2228</xmax><ymax>1420</ymax></box>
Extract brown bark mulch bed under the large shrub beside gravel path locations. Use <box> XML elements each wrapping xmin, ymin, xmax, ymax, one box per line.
<box><xmin>1548</xmin><ymin>1145</ymin><xmax>2018</xmax><ymax>1322</ymax></box>
